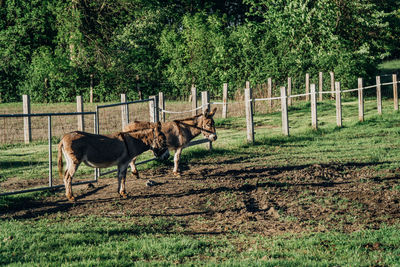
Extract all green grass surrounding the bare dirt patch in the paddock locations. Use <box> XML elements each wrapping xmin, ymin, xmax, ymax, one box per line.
<box><xmin>0</xmin><ymin>99</ymin><xmax>400</xmax><ymax>266</ymax></box>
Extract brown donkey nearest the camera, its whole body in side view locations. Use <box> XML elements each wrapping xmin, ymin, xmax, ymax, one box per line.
<box><xmin>58</xmin><ymin>123</ymin><xmax>167</xmax><ymax>201</ymax></box>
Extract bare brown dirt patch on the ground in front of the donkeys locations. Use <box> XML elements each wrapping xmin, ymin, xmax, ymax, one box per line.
<box><xmin>0</xmin><ymin>156</ymin><xmax>400</xmax><ymax>236</ymax></box>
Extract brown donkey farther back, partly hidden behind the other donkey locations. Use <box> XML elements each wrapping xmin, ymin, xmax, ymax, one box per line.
<box><xmin>123</xmin><ymin>108</ymin><xmax>217</xmax><ymax>178</ymax></box>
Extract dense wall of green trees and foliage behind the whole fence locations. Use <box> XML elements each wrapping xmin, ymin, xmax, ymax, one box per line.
<box><xmin>0</xmin><ymin>0</ymin><xmax>400</xmax><ymax>102</ymax></box>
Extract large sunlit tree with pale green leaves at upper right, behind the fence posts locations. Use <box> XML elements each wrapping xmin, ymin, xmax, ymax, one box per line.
<box><xmin>245</xmin><ymin>0</ymin><xmax>387</xmax><ymax>89</ymax></box>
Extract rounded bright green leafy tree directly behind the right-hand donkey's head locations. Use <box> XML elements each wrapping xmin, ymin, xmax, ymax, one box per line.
<box><xmin>159</xmin><ymin>13</ymin><xmax>229</xmax><ymax>96</ymax></box>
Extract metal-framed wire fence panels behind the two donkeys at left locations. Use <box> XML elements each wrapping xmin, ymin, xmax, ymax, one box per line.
<box><xmin>0</xmin><ymin>98</ymin><xmax>209</xmax><ymax>196</ymax></box>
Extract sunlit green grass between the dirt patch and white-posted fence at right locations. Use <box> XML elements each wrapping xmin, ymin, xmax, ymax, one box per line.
<box><xmin>209</xmin><ymin>100</ymin><xmax>400</xmax><ymax>169</ymax></box>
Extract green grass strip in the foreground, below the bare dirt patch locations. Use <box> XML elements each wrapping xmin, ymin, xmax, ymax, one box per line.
<box><xmin>0</xmin><ymin>217</ymin><xmax>400</xmax><ymax>266</ymax></box>
